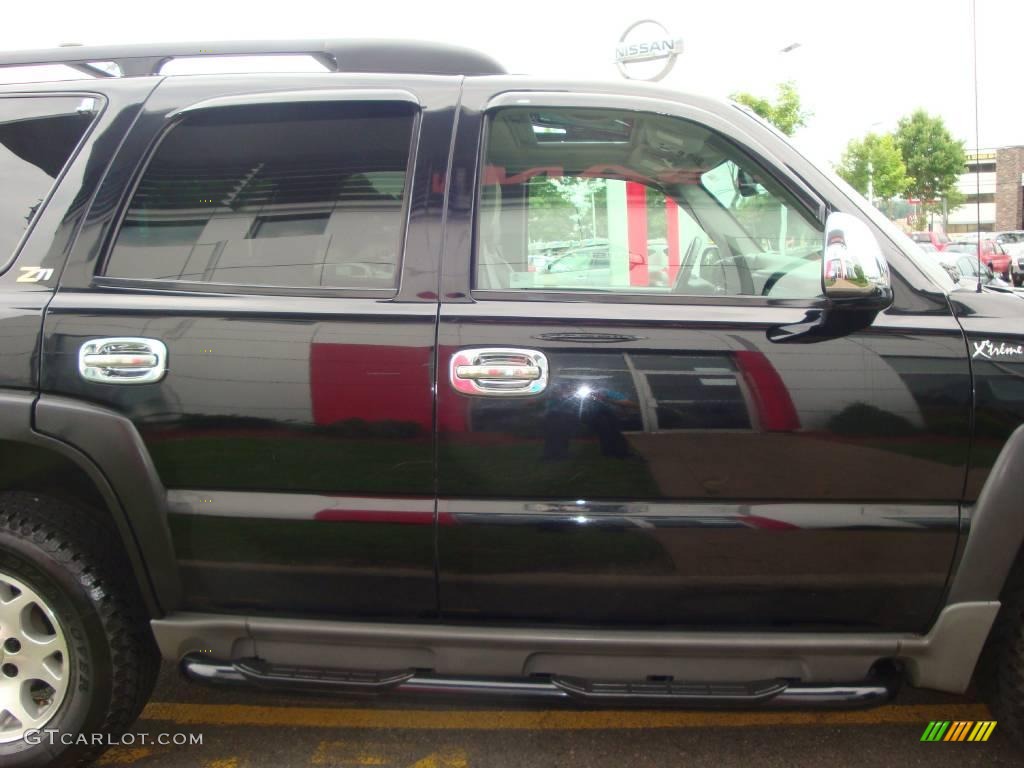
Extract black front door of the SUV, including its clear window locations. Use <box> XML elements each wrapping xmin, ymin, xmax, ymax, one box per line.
<box><xmin>437</xmin><ymin>83</ymin><xmax>970</xmax><ymax>631</ymax></box>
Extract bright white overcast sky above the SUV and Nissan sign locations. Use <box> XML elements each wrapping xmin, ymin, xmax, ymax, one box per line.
<box><xmin>0</xmin><ymin>0</ymin><xmax>1024</xmax><ymax>162</ymax></box>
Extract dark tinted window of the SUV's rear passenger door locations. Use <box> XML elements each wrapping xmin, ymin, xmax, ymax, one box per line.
<box><xmin>105</xmin><ymin>101</ymin><xmax>416</xmax><ymax>290</ymax></box>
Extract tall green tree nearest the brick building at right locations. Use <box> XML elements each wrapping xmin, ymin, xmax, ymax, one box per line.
<box><xmin>895</xmin><ymin>110</ymin><xmax>967</xmax><ymax>225</ymax></box>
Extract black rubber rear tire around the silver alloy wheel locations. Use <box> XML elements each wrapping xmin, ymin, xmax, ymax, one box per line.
<box><xmin>0</xmin><ymin>493</ymin><xmax>160</xmax><ymax>768</ymax></box>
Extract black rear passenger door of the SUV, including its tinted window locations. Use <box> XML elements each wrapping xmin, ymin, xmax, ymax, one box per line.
<box><xmin>41</xmin><ymin>75</ymin><xmax>458</xmax><ymax>618</ymax></box>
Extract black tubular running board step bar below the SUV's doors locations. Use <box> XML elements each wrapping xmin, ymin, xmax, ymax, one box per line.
<box><xmin>181</xmin><ymin>653</ymin><xmax>898</xmax><ymax>709</ymax></box>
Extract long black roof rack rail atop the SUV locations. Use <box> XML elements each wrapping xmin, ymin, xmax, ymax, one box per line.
<box><xmin>0</xmin><ymin>39</ymin><xmax>505</xmax><ymax>78</ymax></box>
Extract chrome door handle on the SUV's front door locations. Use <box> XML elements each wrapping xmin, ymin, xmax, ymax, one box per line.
<box><xmin>449</xmin><ymin>347</ymin><xmax>548</xmax><ymax>397</ymax></box>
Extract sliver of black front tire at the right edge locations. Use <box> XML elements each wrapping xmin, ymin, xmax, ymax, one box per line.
<box><xmin>977</xmin><ymin>560</ymin><xmax>1024</xmax><ymax>748</ymax></box>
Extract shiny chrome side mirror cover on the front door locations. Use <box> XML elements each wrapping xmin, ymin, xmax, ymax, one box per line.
<box><xmin>821</xmin><ymin>213</ymin><xmax>893</xmax><ymax>311</ymax></box>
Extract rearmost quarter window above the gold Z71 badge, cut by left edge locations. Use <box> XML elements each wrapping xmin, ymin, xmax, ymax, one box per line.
<box><xmin>0</xmin><ymin>96</ymin><xmax>98</xmax><ymax>269</ymax></box>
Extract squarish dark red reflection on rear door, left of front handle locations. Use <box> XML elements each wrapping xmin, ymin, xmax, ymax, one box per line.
<box><xmin>309</xmin><ymin>343</ymin><xmax>433</xmax><ymax>434</ymax></box>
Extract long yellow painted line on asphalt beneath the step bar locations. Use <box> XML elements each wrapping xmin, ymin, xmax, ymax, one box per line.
<box><xmin>142</xmin><ymin>702</ymin><xmax>992</xmax><ymax>731</ymax></box>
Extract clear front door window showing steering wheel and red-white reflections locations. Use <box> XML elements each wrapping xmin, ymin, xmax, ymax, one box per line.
<box><xmin>474</xmin><ymin>106</ymin><xmax>823</xmax><ymax>299</ymax></box>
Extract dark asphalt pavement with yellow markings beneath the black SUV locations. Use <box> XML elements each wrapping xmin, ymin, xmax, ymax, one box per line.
<box><xmin>92</xmin><ymin>666</ymin><xmax>1024</xmax><ymax>768</ymax></box>
